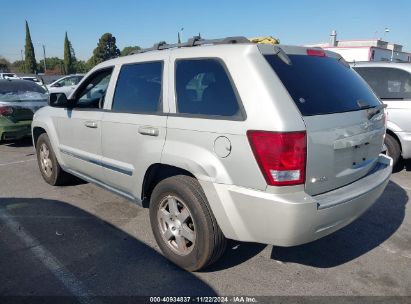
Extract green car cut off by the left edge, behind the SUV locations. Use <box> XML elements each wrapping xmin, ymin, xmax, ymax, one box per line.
<box><xmin>0</xmin><ymin>80</ymin><xmax>48</xmax><ymax>141</ymax></box>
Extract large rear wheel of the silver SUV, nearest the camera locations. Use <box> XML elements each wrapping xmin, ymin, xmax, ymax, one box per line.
<box><xmin>150</xmin><ymin>175</ymin><xmax>227</xmax><ymax>271</ymax></box>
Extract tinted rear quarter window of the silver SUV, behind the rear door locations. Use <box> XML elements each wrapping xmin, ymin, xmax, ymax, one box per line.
<box><xmin>176</xmin><ymin>59</ymin><xmax>242</xmax><ymax>119</ymax></box>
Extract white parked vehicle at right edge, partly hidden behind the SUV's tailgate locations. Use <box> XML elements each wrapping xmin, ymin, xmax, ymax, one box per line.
<box><xmin>352</xmin><ymin>62</ymin><xmax>411</xmax><ymax>164</ymax></box>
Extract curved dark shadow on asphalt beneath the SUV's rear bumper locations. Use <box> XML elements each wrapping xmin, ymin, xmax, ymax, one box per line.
<box><xmin>271</xmin><ymin>181</ymin><xmax>408</xmax><ymax>268</ymax></box>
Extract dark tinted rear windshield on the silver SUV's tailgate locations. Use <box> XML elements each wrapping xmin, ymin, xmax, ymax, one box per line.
<box><xmin>265</xmin><ymin>55</ymin><xmax>380</xmax><ymax>116</ymax></box>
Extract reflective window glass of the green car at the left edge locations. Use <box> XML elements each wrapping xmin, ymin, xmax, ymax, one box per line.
<box><xmin>0</xmin><ymin>81</ymin><xmax>47</xmax><ymax>102</ymax></box>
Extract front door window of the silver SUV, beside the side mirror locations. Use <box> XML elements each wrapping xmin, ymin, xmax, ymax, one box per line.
<box><xmin>76</xmin><ymin>68</ymin><xmax>113</xmax><ymax>109</ymax></box>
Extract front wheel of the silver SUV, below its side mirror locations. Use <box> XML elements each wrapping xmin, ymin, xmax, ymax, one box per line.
<box><xmin>36</xmin><ymin>133</ymin><xmax>72</xmax><ymax>186</ymax></box>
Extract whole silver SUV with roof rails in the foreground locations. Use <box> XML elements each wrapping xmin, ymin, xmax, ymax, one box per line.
<box><xmin>32</xmin><ymin>38</ymin><xmax>392</xmax><ymax>271</ymax></box>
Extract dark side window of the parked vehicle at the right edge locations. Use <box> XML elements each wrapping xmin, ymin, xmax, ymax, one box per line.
<box><xmin>354</xmin><ymin>67</ymin><xmax>411</xmax><ymax>99</ymax></box>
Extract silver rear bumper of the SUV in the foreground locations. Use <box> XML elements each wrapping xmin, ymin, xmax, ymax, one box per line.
<box><xmin>201</xmin><ymin>155</ymin><xmax>392</xmax><ymax>246</ymax></box>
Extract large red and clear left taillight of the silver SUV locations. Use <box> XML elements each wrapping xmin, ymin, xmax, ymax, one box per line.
<box><xmin>247</xmin><ymin>131</ymin><xmax>307</xmax><ymax>186</ymax></box>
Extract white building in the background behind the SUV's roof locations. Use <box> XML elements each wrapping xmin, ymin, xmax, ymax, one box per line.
<box><xmin>306</xmin><ymin>31</ymin><xmax>411</xmax><ymax>62</ymax></box>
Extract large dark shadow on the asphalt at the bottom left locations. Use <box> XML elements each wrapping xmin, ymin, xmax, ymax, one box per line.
<box><xmin>0</xmin><ymin>198</ymin><xmax>216</xmax><ymax>296</ymax></box>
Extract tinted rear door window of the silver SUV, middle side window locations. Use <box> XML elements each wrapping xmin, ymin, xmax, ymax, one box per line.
<box><xmin>112</xmin><ymin>62</ymin><xmax>163</xmax><ymax>113</ymax></box>
